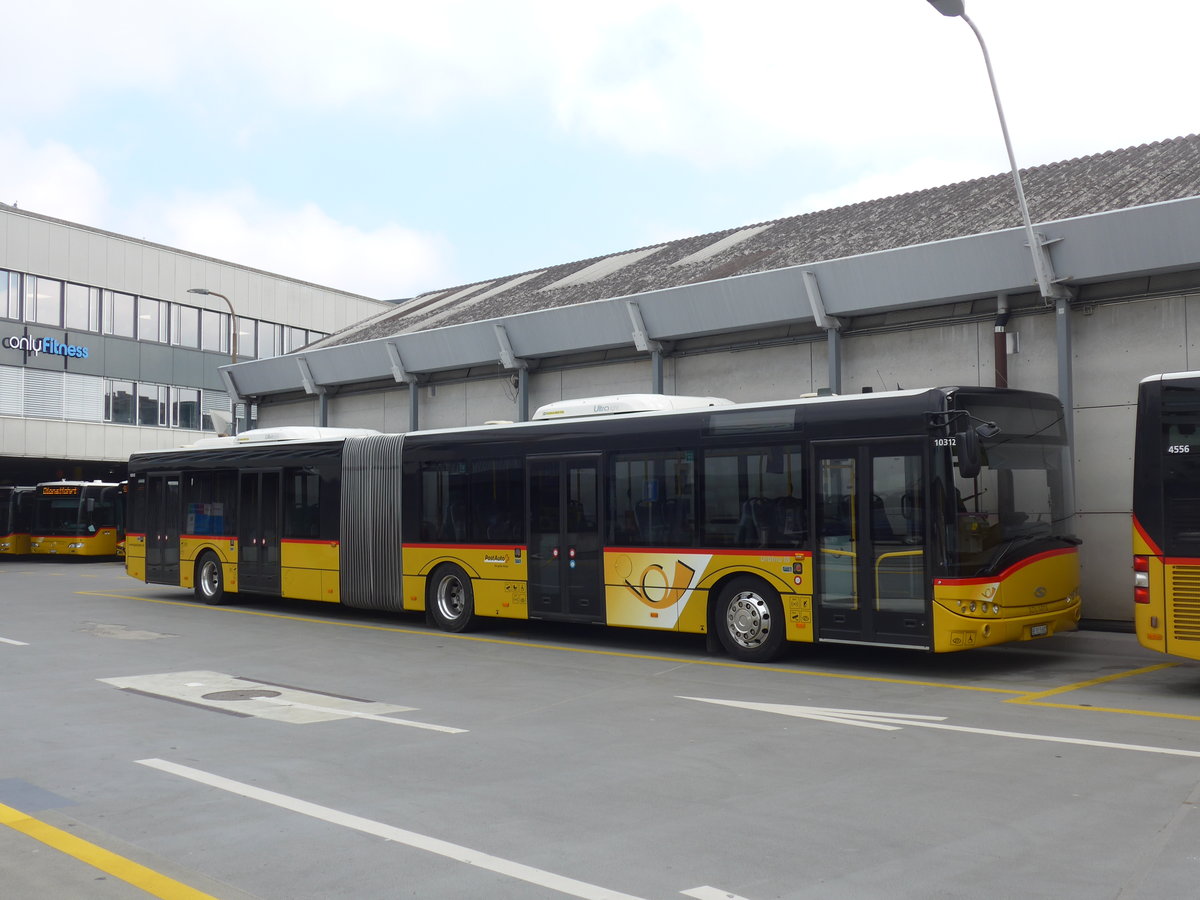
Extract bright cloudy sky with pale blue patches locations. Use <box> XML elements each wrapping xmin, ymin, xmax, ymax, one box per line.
<box><xmin>0</xmin><ymin>0</ymin><xmax>1200</xmax><ymax>299</ymax></box>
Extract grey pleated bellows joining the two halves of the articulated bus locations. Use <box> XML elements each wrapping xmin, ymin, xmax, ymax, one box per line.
<box><xmin>341</xmin><ymin>434</ymin><xmax>404</xmax><ymax>611</ymax></box>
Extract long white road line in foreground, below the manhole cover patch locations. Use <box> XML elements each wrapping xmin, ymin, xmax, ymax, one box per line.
<box><xmin>137</xmin><ymin>760</ymin><xmax>640</xmax><ymax>900</ymax></box>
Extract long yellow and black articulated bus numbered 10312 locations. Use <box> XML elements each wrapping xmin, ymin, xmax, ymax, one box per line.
<box><xmin>126</xmin><ymin>388</ymin><xmax>1080</xmax><ymax>661</ymax></box>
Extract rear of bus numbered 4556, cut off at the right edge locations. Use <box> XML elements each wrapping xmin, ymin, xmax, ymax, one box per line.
<box><xmin>1133</xmin><ymin>372</ymin><xmax>1200</xmax><ymax>659</ymax></box>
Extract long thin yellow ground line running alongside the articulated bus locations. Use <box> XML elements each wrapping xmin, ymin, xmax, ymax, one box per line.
<box><xmin>76</xmin><ymin>590</ymin><xmax>1028</xmax><ymax>695</ymax></box>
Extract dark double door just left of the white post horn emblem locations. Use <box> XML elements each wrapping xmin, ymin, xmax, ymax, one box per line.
<box><xmin>528</xmin><ymin>455</ymin><xmax>605</xmax><ymax>622</ymax></box>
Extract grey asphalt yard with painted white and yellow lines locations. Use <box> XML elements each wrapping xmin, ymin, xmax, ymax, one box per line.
<box><xmin>0</xmin><ymin>560</ymin><xmax>1200</xmax><ymax>900</ymax></box>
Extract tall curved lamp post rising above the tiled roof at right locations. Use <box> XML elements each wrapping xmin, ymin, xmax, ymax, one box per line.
<box><xmin>929</xmin><ymin>0</ymin><xmax>1075</xmax><ymax>512</ymax></box>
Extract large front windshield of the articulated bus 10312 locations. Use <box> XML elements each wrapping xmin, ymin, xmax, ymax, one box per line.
<box><xmin>947</xmin><ymin>394</ymin><xmax>1078</xmax><ymax>577</ymax></box>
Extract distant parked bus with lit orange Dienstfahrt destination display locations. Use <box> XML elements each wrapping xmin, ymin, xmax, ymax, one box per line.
<box><xmin>29</xmin><ymin>481</ymin><xmax>125</xmax><ymax>557</ymax></box>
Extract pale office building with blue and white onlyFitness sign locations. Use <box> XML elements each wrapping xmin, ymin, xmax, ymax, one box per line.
<box><xmin>0</xmin><ymin>204</ymin><xmax>392</xmax><ymax>485</ymax></box>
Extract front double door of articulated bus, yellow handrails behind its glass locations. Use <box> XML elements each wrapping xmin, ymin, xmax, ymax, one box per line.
<box><xmin>814</xmin><ymin>442</ymin><xmax>932</xmax><ymax>647</ymax></box>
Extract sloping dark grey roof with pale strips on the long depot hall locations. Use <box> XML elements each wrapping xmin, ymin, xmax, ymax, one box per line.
<box><xmin>310</xmin><ymin>134</ymin><xmax>1200</xmax><ymax>349</ymax></box>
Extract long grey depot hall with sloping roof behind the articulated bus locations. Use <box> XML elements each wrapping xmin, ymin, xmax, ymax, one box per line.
<box><xmin>228</xmin><ymin>136</ymin><xmax>1200</xmax><ymax>625</ymax></box>
